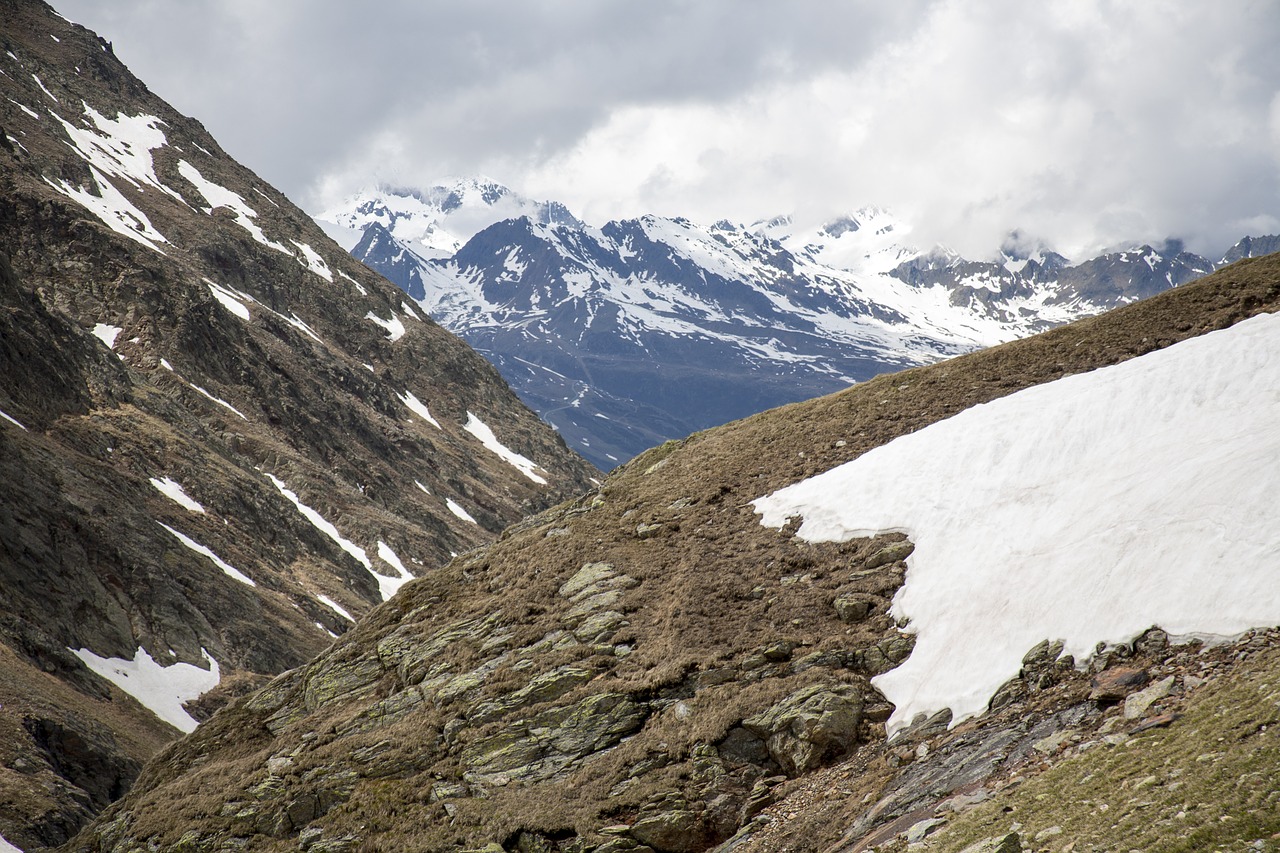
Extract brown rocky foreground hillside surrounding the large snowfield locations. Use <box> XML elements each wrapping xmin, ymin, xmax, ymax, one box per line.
<box><xmin>68</xmin><ymin>244</ymin><xmax>1280</xmax><ymax>853</ymax></box>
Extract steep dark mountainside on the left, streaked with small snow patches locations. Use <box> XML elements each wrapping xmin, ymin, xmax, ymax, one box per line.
<box><xmin>0</xmin><ymin>0</ymin><xmax>595</xmax><ymax>849</ymax></box>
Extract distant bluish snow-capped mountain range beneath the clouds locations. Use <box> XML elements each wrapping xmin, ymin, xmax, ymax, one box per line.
<box><xmin>320</xmin><ymin>181</ymin><xmax>1213</xmax><ymax>467</ymax></box>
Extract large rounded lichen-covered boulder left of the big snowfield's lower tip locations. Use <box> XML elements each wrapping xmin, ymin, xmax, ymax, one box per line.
<box><xmin>742</xmin><ymin>685</ymin><xmax>864</xmax><ymax>776</ymax></box>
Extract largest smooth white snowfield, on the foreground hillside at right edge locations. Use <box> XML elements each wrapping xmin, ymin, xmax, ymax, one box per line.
<box><xmin>755</xmin><ymin>308</ymin><xmax>1280</xmax><ymax>731</ymax></box>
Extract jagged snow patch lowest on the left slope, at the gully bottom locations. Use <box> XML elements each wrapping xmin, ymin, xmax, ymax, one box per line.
<box><xmin>68</xmin><ymin>646</ymin><xmax>220</xmax><ymax>734</ymax></box>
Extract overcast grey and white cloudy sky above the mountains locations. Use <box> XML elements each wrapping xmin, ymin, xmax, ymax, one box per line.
<box><xmin>55</xmin><ymin>0</ymin><xmax>1280</xmax><ymax>257</ymax></box>
